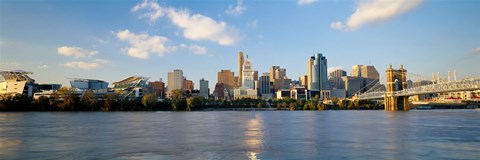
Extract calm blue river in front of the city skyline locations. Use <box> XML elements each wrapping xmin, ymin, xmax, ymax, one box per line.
<box><xmin>0</xmin><ymin>110</ymin><xmax>480</xmax><ymax>159</ymax></box>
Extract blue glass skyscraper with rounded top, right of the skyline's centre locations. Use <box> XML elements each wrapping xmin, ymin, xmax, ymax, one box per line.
<box><xmin>308</xmin><ymin>53</ymin><xmax>328</xmax><ymax>91</ymax></box>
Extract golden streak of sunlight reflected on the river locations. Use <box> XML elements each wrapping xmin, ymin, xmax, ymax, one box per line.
<box><xmin>244</xmin><ymin>114</ymin><xmax>264</xmax><ymax>160</ymax></box>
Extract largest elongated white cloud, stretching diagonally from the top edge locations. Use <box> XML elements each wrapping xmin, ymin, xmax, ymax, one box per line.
<box><xmin>132</xmin><ymin>0</ymin><xmax>242</xmax><ymax>45</ymax></box>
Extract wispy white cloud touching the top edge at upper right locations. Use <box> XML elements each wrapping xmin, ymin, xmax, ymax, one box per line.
<box><xmin>330</xmin><ymin>0</ymin><xmax>422</xmax><ymax>31</ymax></box>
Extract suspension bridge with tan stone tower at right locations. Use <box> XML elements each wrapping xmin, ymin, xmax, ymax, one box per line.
<box><xmin>356</xmin><ymin>65</ymin><xmax>480</xmax><ymax>111</ymax></box>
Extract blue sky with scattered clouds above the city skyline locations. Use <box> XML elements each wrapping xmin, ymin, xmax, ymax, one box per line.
<box><xmin>0</xmin><ymin>0</ymin><xmax>480</xmax><ymax>90</ymax></box>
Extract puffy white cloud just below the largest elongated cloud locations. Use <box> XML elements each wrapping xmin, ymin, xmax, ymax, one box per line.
<box><xmin>116</xmin><ymin>30</ymin><xmax>173</xmax><ymax>59</ymax></box>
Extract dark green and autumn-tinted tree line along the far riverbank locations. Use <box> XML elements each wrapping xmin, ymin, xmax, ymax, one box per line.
<box><xmin>0</xmin><ymin>88</ymin><xmax>383</xmax><ymax>111</ymax></box>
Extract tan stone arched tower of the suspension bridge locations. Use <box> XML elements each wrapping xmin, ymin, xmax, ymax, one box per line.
<box><xmin>384</xmin><ymin>65</ymin><xmax>409</xmax><ymax>111</ymax></box>
